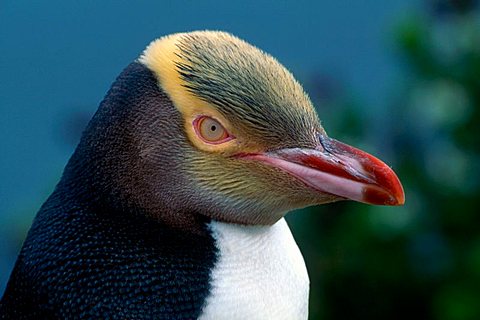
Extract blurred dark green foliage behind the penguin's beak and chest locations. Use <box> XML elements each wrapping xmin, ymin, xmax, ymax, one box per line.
<box><xmin>289</xmin><ymin>0</ymin><xmax>480</xmax><ymax>320</ymax></box>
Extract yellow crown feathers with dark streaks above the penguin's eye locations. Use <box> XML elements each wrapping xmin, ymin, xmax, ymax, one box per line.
<box><xmin>140</xmin><ymin>31</ymin><xmax>323</xmax><ymax>151</ymax></box>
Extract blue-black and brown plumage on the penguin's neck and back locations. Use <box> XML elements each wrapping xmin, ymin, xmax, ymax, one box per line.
<box><xmin>0</xmin><ymin>62</ymin><xmax>216</xmax><ymax>319</ymax></box>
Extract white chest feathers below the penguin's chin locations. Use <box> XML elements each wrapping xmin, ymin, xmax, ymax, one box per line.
<box><xmin>200</xmin><ymin>219</ymin><xmax>309</xmax><ymax>319</ymax></box>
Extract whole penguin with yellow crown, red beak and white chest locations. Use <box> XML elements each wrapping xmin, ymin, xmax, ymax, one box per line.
<box><xmin>0</xmin><ymin>31</ymin><xmax>405</xmax><ymax>319</ymax></box>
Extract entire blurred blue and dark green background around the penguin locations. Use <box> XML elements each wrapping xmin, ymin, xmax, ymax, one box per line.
<box><xmin>0</xmin><ymin>0</ymin><xmax>480</xmax><ymax>320</ymax></box>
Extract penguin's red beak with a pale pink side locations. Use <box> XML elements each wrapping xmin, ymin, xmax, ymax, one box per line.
<box><xmin>241</xmin><ymin>136</ymin><xmax>405</xmax><ymax>206</ymax></box>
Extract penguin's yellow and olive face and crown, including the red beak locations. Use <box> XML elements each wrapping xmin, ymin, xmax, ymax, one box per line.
<box><xmin>136</xmin><ymin>31</ymin><xmax>403</xmax><ymax>224</ymax></box>
